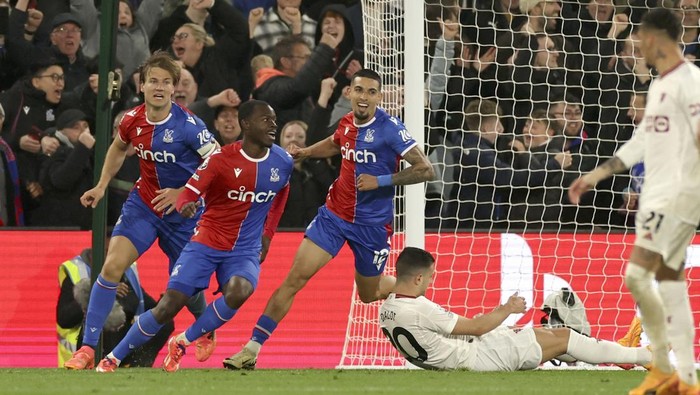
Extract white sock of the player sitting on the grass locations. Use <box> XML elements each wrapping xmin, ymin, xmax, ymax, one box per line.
<box><xmin>566</xmin><ymin>331</ymin><xmax>651</xmax><ymax>365</ymax></box>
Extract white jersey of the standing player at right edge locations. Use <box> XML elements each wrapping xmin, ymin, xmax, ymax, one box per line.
<box><xmin>615</xmin><ymin>61</ymin><xmax>700</xmax><ymax>224</ymax></box>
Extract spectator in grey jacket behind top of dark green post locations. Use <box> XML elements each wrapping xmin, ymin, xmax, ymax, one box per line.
<box><xmin>70</xmin><ymin>0</ymin><xmax>163</xmax><ymax>75</ymax></box>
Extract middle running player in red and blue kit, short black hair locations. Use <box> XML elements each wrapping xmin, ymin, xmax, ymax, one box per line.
<box><xmin>97</xmin><ymin>100</ymin><xmax>294</xmax><ymax>372</ymax></box>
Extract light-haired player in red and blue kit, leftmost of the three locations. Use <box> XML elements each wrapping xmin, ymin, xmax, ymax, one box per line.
<box><xmin>64</xmin><ymin>52</ymin><xmax>218</xmax><ymax>369</ymax></box>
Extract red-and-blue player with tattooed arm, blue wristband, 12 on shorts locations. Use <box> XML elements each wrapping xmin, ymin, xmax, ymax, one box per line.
<box><xmin>224</xmin><ymin>69</ymin><xmax>434</xmax><ymax>369</ymax></box>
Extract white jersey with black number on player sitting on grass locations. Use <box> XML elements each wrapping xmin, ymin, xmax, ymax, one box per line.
<box><xmin>379</xmin><ymin>294</ymin><xmax>476</xmax><ymax>369</ymax></box>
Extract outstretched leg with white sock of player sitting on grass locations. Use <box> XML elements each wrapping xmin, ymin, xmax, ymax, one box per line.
<box><xmin>534</xmin><ymin>328</ymin><xmax>651</xmax><ymax>365</ymax></box>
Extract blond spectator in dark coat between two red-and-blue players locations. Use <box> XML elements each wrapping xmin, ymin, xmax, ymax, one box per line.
<box><xmin>279</xmin><ymin>121</ymin><xmax>336</xmax><ymax>229</ymax></box>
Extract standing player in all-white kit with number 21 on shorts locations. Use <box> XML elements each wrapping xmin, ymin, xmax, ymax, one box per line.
<box><xmin>569</xmin><ymin>8</ymin><xmax>700</xmax><ymax>395</ymax></box>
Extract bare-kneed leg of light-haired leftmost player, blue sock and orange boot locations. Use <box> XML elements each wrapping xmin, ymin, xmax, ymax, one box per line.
<box><xmin>63</xmin><ymin>236</ymin><xmax>138</xmax><ymax>370</ymax></box>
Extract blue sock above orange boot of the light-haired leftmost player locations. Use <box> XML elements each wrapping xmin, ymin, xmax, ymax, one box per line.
<box><xmin>83</xmin><ymin>274</ymin><xmax>117</xmax><ymax>348</ymax></box>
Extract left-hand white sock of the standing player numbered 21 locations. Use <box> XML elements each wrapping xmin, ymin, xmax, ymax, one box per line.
<box><xmin>625</xmin><ymin>262</ymin><xmax>674</xmax><ymax>374</ymax></box>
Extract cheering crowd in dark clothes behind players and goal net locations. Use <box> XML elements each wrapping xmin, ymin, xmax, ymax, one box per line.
<box><xmin>0</xmin><ymin>0</ymin><xmax>688</xmax><ymax>230</ymax></box>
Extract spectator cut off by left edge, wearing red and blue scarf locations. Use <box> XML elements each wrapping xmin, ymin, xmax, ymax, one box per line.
<box><xmin>0</xmin><ymin>106</ymin><xmax>24</xmax><ymax>226</ymax></box>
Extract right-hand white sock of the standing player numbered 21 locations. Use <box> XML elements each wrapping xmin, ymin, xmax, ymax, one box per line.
<box><xmin>659</xmin><ymin>281</ymin><xmax>698</xmax><ymax>385</ymax></box>
